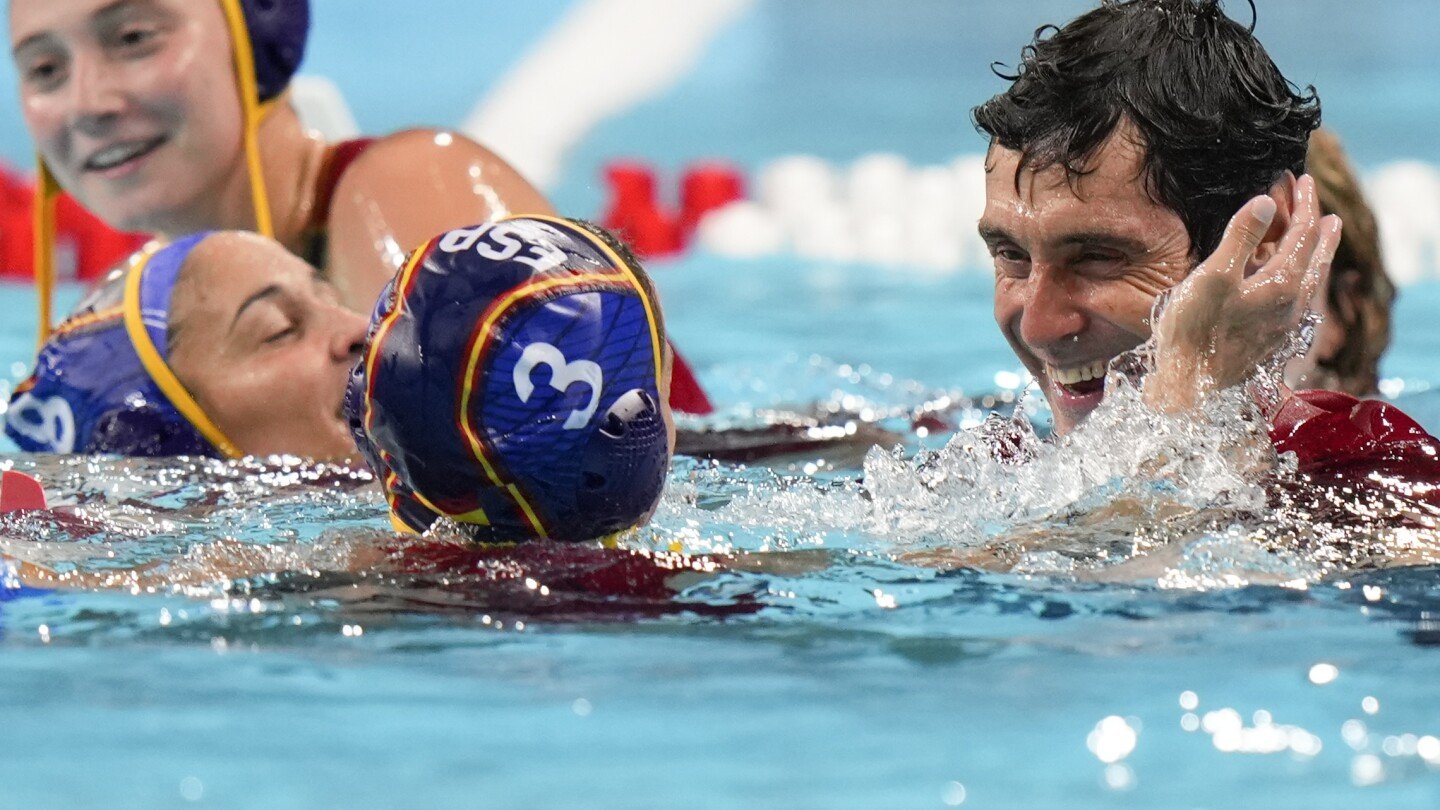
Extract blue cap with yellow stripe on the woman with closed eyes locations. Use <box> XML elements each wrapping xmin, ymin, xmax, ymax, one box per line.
<box><xmin>4</xmin><ymin>233</ymin><xmax>239</xmax><ymax>457</ymax></box>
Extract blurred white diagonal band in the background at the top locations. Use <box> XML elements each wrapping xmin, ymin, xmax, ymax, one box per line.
<box><xmin>461</xmin><ymin>0</ymin><xmax>755</xmax><ymax>189</ymax></box>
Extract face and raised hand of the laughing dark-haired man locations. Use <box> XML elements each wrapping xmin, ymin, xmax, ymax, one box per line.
<box><xmin>979</xmin><ymin>124</ymin><xmax>1341</xmax><ymax>432</ymax></box>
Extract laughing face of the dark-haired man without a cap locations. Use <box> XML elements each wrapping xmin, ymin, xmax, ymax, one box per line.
<box><xmin>979</xmin><ymin>125</ymin><xmax>1195</xmax><ymax>432</ymax></box>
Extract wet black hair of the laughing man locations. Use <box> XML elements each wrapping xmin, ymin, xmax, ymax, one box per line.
<box><xmin>973</xmin><ymin>0</ymin><xmax>1320</xmax><ymax>258</ymax></box>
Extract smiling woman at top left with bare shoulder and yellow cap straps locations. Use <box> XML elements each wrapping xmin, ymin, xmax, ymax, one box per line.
<box><xmin>10</xmin><ymin>0</ymin><xmax>711</xmax><ymax>414</ymax></box>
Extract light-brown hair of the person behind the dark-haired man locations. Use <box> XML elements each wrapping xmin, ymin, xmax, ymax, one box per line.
<box><xmin>1306</xmin><ymin>130</ymin><xmax>1395</xmax><ymax>396</ymax></box>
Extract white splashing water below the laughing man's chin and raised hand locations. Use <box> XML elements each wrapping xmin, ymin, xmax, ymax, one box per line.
<box><xmin>655</xmin><ymin>337</ymin><xmax>1440</xmax><ymax>589</ymax></box>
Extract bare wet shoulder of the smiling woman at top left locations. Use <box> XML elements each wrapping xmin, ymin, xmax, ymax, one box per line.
<box><xmin>325</xmin><ymin>130</ymin><xmax>554</xmax><ymax>313</ymax></box>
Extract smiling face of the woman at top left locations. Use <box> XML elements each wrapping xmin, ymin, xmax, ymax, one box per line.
<box><xmin>10</xmin><ymin>0</ymin><xmax>245</xmax><ymax>233</ymax></box>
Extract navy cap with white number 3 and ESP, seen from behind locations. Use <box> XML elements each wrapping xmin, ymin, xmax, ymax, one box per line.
<box><xmin>346</xmin><ymin>216</ymin><xmax>671</xmax><ymax>542</ymax></box>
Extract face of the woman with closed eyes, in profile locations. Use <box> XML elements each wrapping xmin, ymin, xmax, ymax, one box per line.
<box><xmin>170</xmin><ymin>233</ymin><xmax>366</xmax><ymax>458</ymax></box>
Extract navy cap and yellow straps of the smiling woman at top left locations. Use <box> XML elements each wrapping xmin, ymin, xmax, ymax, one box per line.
<box><xmin>33</xmin><ymin>0</ymin><xmax>310</xmax><ymax>346</ymax></box>
